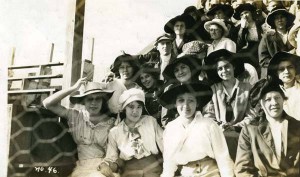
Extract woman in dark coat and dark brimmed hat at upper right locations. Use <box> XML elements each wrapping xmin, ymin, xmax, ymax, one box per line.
<box><xmin>258</xmin><ymin>8</ymin><xmax>295</xmax><ymax>78</ymax></box>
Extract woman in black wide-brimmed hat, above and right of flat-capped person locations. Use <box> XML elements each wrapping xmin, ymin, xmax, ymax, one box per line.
<box><xmin>164</xmin><ymin>14</ymin><xmax>195</xmax><ymax>56</ymax></box>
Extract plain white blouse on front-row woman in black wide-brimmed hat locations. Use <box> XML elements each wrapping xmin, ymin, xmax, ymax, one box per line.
<box><xmin>162</xmin><ymin>112</ymin><xmax>234</xmax><ymax>177</ymax></box>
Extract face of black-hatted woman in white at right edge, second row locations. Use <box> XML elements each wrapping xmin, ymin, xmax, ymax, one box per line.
<box><xmin>277</xmin><ymin>61</ymin><xmax>296</xmax><ymax>84</ymax></box>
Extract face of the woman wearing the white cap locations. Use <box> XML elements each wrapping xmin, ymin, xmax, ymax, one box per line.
<box><xmin>125</xmin><ymin>101</ymin><xmax>143</xmax><ymax>123</ymax></box>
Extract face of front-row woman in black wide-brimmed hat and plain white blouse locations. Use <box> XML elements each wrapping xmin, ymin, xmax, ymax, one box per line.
<box><xmin>175</xmin><ymin>93</ymin><xmax>197</xmax><ymax>119</ymax></box>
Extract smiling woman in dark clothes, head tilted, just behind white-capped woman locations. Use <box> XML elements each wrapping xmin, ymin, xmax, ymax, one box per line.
<box><xmin>137</xmin><ymin>63</ymin><xmax>164</xmax><ymax>125</ymax></box>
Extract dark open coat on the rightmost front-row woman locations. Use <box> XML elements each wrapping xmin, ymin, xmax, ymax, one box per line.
<box><xmin>235</xmin><ymin>113</ymin><xmax>300</xmax><ymax>177</ymax></box>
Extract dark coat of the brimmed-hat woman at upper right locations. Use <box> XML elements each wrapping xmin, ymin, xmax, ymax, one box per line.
<box><xmin>258</xmin><ymin>31</ymin><xmax>294</xmax><ymax>78</ymax></box>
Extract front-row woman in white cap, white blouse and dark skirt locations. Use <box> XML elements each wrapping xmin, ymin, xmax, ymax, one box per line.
<box><xmin>99</xmin><ymin>88</ymin><xmax>163</xmax><ymax>177</ymax></box>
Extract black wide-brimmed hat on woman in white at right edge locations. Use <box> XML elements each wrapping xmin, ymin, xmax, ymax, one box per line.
<box><xmin>267</xmin><ymin>52</ymin><xmax>300</xmax><ymax>77</ymax></box>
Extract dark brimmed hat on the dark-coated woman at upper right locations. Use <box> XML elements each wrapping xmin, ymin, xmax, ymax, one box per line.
<box><xmin>266</xmin><ymin>9</ymin><xmax>296</xmax><ymax>29</ymax></box>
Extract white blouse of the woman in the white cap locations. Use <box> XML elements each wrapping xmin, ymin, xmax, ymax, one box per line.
<box><xmin>105</xmin><ymin>115</ymin><xmax>163</xmax><ymax>162</ymax></box>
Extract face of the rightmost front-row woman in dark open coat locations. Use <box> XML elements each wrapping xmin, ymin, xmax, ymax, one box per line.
<box><xmin>260</xmin><ymin>91</ymin><xmax>284</xmax><ymax>120</ymax></box>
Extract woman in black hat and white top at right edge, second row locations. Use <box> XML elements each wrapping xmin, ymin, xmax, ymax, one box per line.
<box><xmin>268</xmin><ymin>52</ymin><xmax>300</xmax><ymax>120</ymax></box>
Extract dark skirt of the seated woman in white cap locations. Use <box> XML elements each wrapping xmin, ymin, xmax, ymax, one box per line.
<box><xmin>121</xmin><ymin>155</ymin><xmax>163</xmax><ymax>177</ymax></box>
